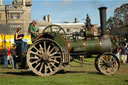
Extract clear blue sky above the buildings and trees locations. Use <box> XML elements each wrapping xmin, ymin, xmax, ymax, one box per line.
<box><xmin>3</xmin><ymin>0</ymin><xmax>128</xmax><ymax>26</ymax></box>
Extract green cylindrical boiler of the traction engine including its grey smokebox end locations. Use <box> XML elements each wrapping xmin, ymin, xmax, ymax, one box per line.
<box><xmin>70</xmin><ymin>38</ymin><xmax>112</xmax><ymax>54</ymax></box>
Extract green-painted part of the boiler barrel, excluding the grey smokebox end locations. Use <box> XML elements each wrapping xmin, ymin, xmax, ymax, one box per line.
<box><xmin>70</xmin><ymin>39</ymin><xmax>100</xmax><ymax>54</ymax></box>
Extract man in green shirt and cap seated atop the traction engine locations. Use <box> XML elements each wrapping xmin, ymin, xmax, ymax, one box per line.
<box><xmin>29</xmin><ymin>20</ymin><xmax>39</xmax><ymax>42</ymax></box>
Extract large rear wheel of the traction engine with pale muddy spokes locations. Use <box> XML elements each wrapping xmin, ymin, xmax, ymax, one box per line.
<box><xmin>27</xmin><ymin>39</ymin><xmax>63</xmax><ymax>76</ymax></box>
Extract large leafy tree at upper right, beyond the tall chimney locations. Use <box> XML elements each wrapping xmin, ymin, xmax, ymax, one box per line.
<box><xmin>107</xmin><ymin>3</ymin><xmax>128</xmax><ymax>35</ymax></box>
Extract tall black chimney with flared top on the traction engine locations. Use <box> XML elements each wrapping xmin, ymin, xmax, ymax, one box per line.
<box><xmin>99</xmin><ymin>7</ymin><xmax>107</xmax><ymax>35</ymax></box>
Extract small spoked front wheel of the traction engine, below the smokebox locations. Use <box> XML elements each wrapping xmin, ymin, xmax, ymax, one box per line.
<box><xmin>95</xmin><ymin>53</ymin><xmax>120</xmax><ymax>75</ymax></box>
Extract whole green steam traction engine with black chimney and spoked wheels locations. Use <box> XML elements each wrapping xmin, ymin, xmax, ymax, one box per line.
<box><xmin>27</xmin><ymin>7</ymin><xmax>120</xmax><ymax>76</ymax></box>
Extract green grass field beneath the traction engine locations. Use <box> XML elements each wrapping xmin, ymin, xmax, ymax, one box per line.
<box><xmin>0</xmin><ymin>58</ymin><xmax>128</xmax><ymax>85</ymax></box>
